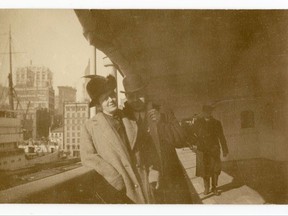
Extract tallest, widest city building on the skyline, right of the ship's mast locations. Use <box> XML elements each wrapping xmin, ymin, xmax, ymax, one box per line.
<box><xmin>14</xmin><ymin>65</ymin><xmax>55</xmax><ymax>138</ymax></box>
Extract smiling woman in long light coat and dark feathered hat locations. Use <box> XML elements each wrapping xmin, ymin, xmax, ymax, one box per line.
<box><xmin>80</xmin><ymin>75</ymin><xmax>158</xmax><ymax>204</ymax></box>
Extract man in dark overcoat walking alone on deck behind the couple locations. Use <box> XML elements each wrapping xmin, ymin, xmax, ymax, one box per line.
<box><xmin>193</xmin><ymin>105</ymin><xmax>228</xmax><ymax>195</ymax></box>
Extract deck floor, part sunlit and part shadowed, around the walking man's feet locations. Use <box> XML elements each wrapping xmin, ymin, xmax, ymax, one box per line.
<box><xmin>177</xmin><ymin>148</ymin><xmax>288</xmax><ymax>204</ymax></box>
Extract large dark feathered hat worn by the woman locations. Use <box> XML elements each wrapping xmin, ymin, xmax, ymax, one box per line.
<box><xmin>84</xmin><ymin>75</ymin><xmax>117</xmax><ymax>108</ymax></box>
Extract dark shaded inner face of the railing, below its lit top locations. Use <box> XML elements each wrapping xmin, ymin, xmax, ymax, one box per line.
<box><xmin>4</xmin><ymin>171</ymin><xmax>133</xmax><ymax>204</ymax></box>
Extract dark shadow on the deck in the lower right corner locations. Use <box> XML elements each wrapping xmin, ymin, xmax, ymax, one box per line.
<box><xmin>222</xmin><ymin>159</ymin><xmax>288</xmax><ymax>204</ymax></box>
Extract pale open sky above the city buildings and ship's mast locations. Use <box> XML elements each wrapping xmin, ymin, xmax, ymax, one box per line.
<box><xmin>0</xmin><ymin>9</ymin><xmax>91</xmax><ymax>99</ymax></box>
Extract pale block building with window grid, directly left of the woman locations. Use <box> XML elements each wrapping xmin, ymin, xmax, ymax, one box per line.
<box><xmin>63</xmin><ymin>102</ymin><xmax>90</xmax><ymax>157</ymax></box>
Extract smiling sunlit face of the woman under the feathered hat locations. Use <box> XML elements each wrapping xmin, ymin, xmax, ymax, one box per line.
<box><xmin>99</xmin><ymin>91</ymin><xmax>117</xmax><ymax>114</ymax></box>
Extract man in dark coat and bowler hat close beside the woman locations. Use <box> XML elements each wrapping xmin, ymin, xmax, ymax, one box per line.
<box><xmin>123</xmin><ymin>75</ymin><xmax>192</xmax><ymax>204</ymax></box>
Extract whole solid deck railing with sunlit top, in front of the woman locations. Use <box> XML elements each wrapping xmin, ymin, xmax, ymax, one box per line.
<box><xmin>0</xmin><ymin>166</ymin><xmax>132</xmax><ymax>204</ymax></box>
